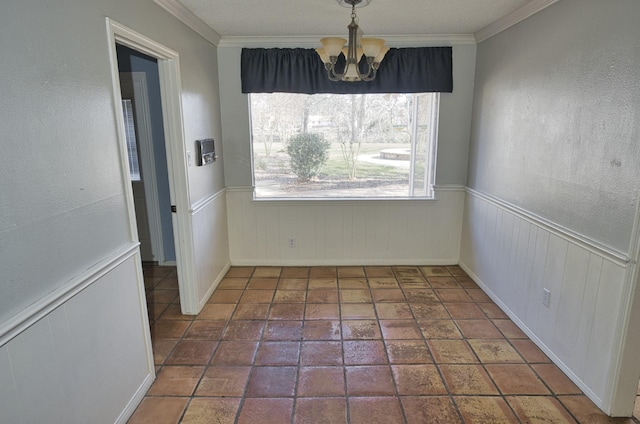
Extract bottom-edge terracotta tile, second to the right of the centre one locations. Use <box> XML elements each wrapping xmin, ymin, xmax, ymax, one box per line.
<box><xmin>400</xmin><ymin>396</ymin><xmax>462</xmax><ymax>424</ymax></box>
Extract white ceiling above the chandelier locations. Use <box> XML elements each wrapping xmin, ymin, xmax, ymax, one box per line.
<box><xmin>174</xmin><ymin>0</ymin><xmax>548</xmax><ymax>39</ymax></box>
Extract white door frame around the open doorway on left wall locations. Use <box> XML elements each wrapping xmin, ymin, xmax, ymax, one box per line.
<box><xmin>105</xmin><ymin>17</ymin><xmax>198</xmax><ymax>315</ymax></box>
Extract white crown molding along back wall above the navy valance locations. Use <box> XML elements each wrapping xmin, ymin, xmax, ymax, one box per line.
<box><xmin>218</xmin><ymin>33</ymin><xmax>476</xmax><ymax>48</ymax></box>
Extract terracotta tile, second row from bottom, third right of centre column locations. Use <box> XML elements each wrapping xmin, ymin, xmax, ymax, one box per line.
<box><xmin>440</xmin><ymin>365</ymin><xmax>500</xmax><ymax>396</ymax></box>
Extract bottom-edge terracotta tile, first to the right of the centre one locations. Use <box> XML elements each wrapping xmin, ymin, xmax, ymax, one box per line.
<box><xmin>349</xmin><ymin>397</ymin><xmax>404</xmax><ymax>424</ymax></box>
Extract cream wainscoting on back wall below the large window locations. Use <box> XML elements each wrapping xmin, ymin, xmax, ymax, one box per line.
<box><xmin>227</xmin><ymin>187</ymin><xmax>464</xmax><ymax>265</ymax></box>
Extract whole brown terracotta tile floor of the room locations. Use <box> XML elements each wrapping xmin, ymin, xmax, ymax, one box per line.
<box><xmin>129</xmin><ymin>266</ymin><xmax>640</xmax><ymax>424</ymax></box>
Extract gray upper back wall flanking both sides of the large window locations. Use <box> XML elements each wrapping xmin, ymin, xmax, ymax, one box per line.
<box><xmin>218</xmin><ymin>44</ymin><xmax>476</xmax><ymax>187</ymax></box>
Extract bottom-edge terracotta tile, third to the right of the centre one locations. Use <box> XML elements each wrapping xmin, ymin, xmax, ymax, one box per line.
<box><xmin>454</xmin><ymin>396</ymin><xmax>518</xmax><ymax>424</ymax></box>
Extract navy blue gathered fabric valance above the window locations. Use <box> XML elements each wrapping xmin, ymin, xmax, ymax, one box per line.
<box><xmin>241</xmin><ymin>47</ymin><xmax>453</xmax><ymax>94</ymax></box>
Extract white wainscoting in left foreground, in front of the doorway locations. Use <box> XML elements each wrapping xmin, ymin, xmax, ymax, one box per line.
<box><xmin>0</xmin><ymin>247</ymin><xmax>155</xmax><ymax>424</ymax></box>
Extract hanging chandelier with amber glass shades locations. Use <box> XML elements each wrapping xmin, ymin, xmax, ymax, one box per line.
<box><xmin>316</xmin><ymin>0</ymin><xmax>389</xmax><ymax>82</ymax></box>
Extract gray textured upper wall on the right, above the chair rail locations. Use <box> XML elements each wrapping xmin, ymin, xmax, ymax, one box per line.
<box><xmin>468</xmin><ymin>0</ymin><xmax>640</xmax><ymax>253</ymax></box>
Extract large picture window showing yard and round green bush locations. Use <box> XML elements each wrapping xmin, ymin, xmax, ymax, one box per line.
<box><xmin>250</xmin><ymin>93</ymin><xmax>440</xmax><ymax>199</ymax></box>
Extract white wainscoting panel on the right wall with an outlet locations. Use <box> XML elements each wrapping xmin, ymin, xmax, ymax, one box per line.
<box><xmin>460</xmin><ymin>190</ymin><xmax>628</xmax><ymax>407</ymax></box>
